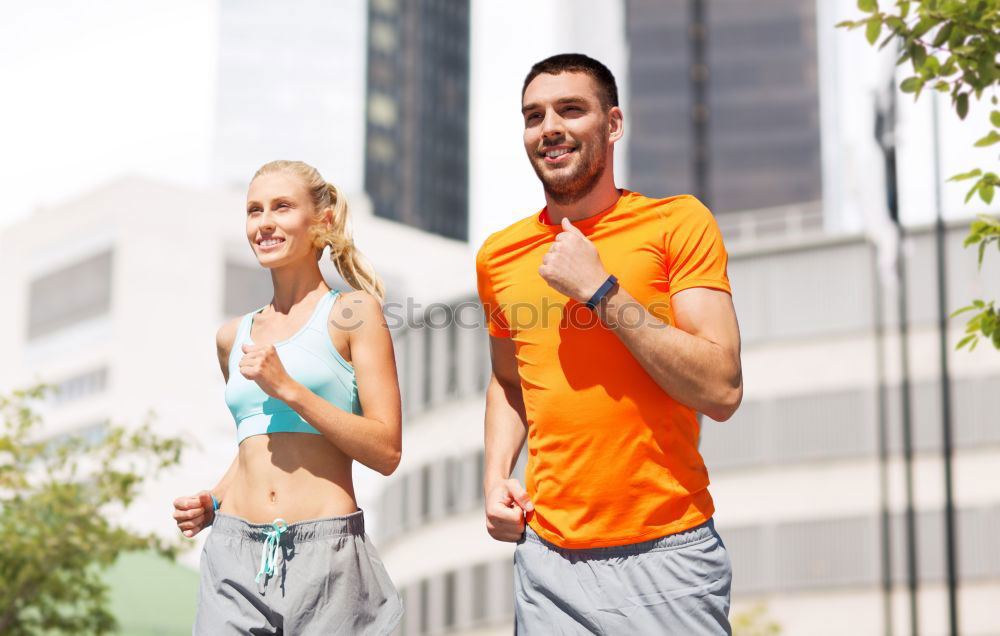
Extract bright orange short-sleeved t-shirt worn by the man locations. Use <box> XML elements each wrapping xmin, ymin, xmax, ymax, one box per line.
<box><xmin>476</xmin><ymin>190</ymin><xmax>730</xmax><ymax>548</ymax></box>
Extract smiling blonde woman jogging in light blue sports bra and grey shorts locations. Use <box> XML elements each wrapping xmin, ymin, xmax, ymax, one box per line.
<box><xmin>174</xmin><ymin>161</ymin><xmax>402</xmax><ymax>636</ymax></box>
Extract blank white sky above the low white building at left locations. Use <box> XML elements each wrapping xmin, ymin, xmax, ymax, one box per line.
<box><xmin>0</xmin><ymin>0</ymin><xmax>216</xmax><ymax>227</ymax></box>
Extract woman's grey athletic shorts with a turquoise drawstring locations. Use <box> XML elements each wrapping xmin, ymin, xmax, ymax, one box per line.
<box><xmin>193</xmin><ymin>510</ymin><xmax>403</xmax><ymax>636</ymax></box>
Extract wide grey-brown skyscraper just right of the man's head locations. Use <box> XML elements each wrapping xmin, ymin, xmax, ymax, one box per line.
<box><xmin>626</xmin><ymin>0</ymin><xmax>822</xmax><ymax>213</ymax></box>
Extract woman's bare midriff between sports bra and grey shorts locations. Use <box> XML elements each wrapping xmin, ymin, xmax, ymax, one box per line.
<box><xmin>219</xmin><ymin>433</ymin><xmax>358</xmax><ymax>523</ymax></box>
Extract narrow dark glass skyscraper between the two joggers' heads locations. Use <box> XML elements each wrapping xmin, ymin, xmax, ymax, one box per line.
<box><xmin>365</xmin><ymin>0</ymin><xmax>469</xmax><ymax>240</ymax></box>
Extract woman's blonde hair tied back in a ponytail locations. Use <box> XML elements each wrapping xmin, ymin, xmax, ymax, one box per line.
<box><xmin>251</xmin><ymin>160</ymin><xmax>385</xmax><ymax>302</ymax></box>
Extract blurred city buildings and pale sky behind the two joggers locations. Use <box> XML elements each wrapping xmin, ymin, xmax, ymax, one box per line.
<box><xmin>0</xmin><ymin>0</ymin><xmax>1000</xmax><ymax>636</ymax></box>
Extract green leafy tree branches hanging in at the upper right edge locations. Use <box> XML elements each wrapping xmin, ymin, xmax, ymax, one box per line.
<box><xmin>837</xmin><ymin>0</ymin><xmax>1000</xmax><ymax>350</ymax></box>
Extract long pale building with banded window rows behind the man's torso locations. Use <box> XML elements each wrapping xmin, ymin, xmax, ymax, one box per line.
<box><xmin>376</xmin><ymin>219</ymin><xmax>1000</xmax><ymax>636</ymax></box>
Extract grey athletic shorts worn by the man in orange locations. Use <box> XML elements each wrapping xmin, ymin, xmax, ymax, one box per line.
<box><xmin>514</xmin><ymin>520</ymin><xmax>732</xmax><ymax>636</ymax></box>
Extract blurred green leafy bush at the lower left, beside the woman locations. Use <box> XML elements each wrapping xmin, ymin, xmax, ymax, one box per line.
<box><xmin>0</xmin><ymin>386</ymin><xmax>183</xmax><ymax>636</ymax></box>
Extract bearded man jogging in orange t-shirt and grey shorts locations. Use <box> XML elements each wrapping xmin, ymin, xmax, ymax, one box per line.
<box><xmin>476</xmin><ymin>54</ymin><xmax>743</xmax><ymax>634</ymax></box>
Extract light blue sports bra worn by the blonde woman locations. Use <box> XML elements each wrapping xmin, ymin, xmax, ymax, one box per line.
<box><xmin>226</xmin><ymin>289</ymin><xmax>361</xmax><ymax>443</ymax></box>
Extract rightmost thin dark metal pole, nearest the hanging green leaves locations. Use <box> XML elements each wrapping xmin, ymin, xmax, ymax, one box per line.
<box><xmin>931</xmin><ymin>92</ymin><xmax>958</xmax><ymax>636</ymax></box>
